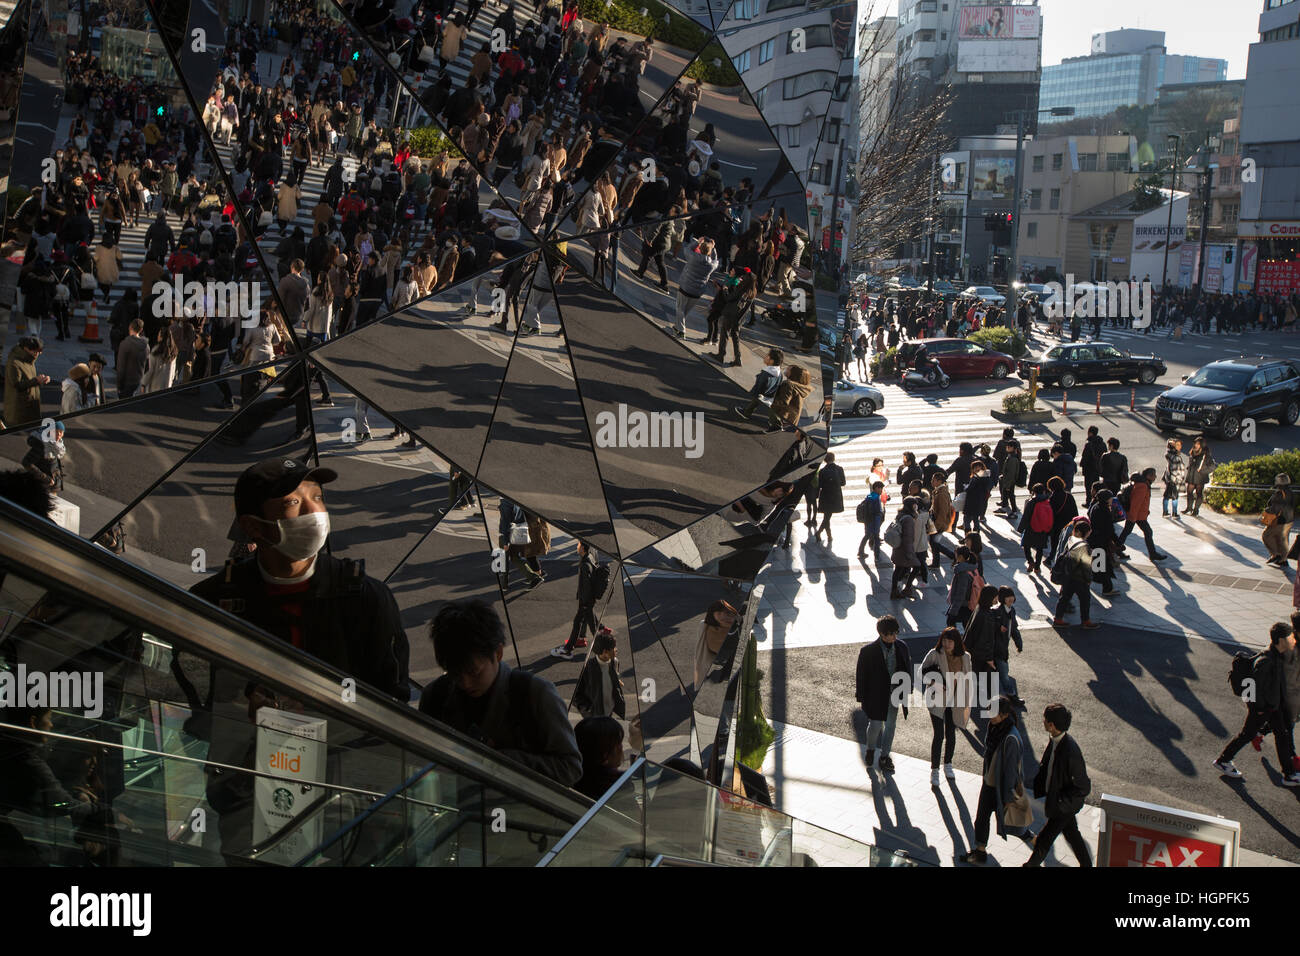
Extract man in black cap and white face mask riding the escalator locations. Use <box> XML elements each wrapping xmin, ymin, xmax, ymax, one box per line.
<box><xmin>190</xmin><ymin>458</ymin><xmax>410</xmax><ymax>701</ymax></box>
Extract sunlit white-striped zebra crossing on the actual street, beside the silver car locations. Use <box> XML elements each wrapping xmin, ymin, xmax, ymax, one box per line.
<box><xmin>829</xmin><ymin>385</ymin><xmax>1054</xmax><ymax>502</ymax></box>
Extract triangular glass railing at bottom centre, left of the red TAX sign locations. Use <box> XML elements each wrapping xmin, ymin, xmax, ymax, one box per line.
<box><xmin>540</xmin><ymin>758</ymin><xmax>917</xmax><ymax>866</ymax></box>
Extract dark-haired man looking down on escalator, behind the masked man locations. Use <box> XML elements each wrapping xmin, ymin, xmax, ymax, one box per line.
<box><xmin>420</xmin><ymin>600</ymin><xmax>582</xmax><ymax>787</ymax></box>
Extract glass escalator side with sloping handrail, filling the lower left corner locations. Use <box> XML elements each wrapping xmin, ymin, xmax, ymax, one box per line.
<box><xmin>0</xmin><ymin>502</ymin><xmax>592</xmax><ymax>866</ymax></box>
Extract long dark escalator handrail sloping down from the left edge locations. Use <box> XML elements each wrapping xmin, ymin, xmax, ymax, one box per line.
<box><xmin>0</xmin><ymin>498</ymin><xmax>590</xmax><ymax>821</ymax></box>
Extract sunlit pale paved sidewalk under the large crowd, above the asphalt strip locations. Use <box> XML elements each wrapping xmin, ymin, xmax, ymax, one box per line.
<box><xmin>755</xmin><ymin>502</ymin><xmax>1295</xmax><ymax>650</ymax></box>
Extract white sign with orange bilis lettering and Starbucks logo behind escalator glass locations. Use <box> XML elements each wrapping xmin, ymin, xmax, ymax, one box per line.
<box><xmin>252</xmin><ymin>708</ymin><xmax>329</xmax><ymax>866</ymax></box>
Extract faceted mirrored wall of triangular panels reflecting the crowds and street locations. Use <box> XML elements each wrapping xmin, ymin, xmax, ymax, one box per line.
<box><xmin>0</xmin><ymin>0</ymin><xmax>852</xmax><ymax>758</ymax></box>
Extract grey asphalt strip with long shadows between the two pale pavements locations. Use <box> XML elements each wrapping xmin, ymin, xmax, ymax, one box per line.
<box><xmin>758</xmin><ymin>627</ymin><xmax>1300</xmax><ymax>862</ymax></box>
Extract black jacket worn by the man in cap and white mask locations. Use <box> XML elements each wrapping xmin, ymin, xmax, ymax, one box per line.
<box><xmin>190</xmin><ymin>551</ymin><xmax>410</xmax><ymax>701</ymax></box>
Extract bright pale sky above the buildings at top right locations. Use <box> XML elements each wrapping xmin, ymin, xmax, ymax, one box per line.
<box><xmin>858</xmin><ymin>0</ymin><xmax>1264</xmax><ymax>79</ymax></box>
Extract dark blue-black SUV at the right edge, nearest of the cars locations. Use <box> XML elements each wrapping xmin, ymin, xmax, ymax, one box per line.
<box><xmin>1156</xmin><ymin>356</ymin><xmax>1300</xmax><ymax>440</ymax></box>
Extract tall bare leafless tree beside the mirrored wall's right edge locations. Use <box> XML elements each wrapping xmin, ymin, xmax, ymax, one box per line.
<box><xmin>853</xmin><ymin>9</ymin><xmax>953</xmax><ymax>269</ymax></box>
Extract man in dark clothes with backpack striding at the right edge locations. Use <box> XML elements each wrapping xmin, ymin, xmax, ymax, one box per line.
<box><xmin>1214</xmin><ymin>621</ymin><xmax>1300</xmax><ymax>787</ymax></box>
